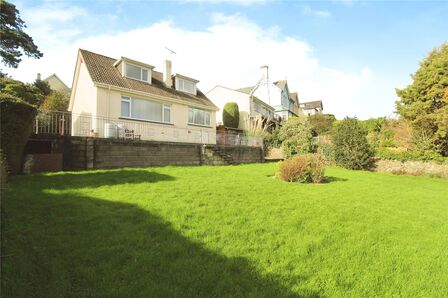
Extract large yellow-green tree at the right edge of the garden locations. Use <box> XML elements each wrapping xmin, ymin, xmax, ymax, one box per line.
<box><xmin>396</xmin><ymin>43</ymin><xmax>448</xmax><ymax>156</ymax></box>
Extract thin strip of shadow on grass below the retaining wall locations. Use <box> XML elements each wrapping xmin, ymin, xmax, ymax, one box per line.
<box><xmin>27</xmin><ymin>169</ymin><xmax>175</xmax><ymax>189</ymax></box>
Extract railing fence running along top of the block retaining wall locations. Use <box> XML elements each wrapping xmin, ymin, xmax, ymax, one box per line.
<box><xmin>33</xmin><ymin>111</ymin><xmax>263</xmax><ymax>147</ymax></box>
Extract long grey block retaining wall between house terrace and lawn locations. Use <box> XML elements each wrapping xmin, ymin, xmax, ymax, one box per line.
<box><xmin>25</xmin><ymin>136</ymin><xmax>264</xmax><ymax>171</ymax></box>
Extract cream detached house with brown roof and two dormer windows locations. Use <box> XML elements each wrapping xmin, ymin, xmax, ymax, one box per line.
<box><xmin>69</xmin><ymin>49</ymin><xmax>217</xmax><ymax>144</ymax></box>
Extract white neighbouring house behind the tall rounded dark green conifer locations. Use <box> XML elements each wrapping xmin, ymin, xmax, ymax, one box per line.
<box><xmin>207</xmin><ymin>85</ymin><xmax>275</xmax><ymax>130</ymax></box>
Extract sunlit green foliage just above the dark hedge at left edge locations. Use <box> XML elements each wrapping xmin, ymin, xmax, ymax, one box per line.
<box><xmin>0</xmin><ymin>78</ymin><xmax>44</xmax><ymax>107</ymax></box>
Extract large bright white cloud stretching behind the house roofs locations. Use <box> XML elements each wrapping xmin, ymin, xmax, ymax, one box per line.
<box><xmin>7</xmin><ymin>14</ymin><xmax>374</xmax><ymax>117</ymax></box>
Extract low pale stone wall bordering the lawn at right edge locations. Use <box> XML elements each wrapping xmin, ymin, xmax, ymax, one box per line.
<box><xmin>376</xmin><ymin>148</ymin><xmax>448</xmax><ymax>163</ymax></box>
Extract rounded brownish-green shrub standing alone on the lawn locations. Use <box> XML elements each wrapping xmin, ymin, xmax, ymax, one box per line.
<box><xmin>277</xmin><ymin>153</ymin><xmax>325</xmax><ymax>183</ymax></box>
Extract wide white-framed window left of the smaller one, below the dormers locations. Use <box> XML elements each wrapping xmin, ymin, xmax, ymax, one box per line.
<box><xmin>121</xmin><ymin>96</ymin><xmax>171</xmax><ymax>123</ymax></box>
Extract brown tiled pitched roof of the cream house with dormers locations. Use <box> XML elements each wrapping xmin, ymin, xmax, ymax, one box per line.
<box><xmin>79</xmin><ymin>49</ymin><xmax>216</xmax><ymax>108</ymax></box>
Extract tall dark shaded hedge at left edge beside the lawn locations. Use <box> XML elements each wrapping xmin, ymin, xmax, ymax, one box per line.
<box><xmin>0</xmin><ymin>93</ymin><xmax>37</xmax><ymax>174</ymax></box>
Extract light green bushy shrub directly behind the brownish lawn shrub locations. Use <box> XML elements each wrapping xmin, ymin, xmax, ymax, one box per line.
<box><xmin>279</xmin><ymin>117</ymin><xmax>316</xmax><ymax>158</ymax></box>
